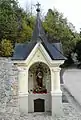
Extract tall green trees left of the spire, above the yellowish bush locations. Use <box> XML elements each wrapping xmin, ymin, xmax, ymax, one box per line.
<box><xmin>0</xmin><ymin>0</ymin><xmax>34</xmax><ymax>44</ymax></box>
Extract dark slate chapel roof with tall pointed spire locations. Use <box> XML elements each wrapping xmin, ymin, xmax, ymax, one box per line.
<box><xmin>12</xmin><ymin>2</ymin><xmax>66</xmax><ymax>60</ymax></box>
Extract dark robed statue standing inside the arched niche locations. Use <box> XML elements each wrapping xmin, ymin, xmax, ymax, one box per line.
<box><xmin>36</xmin><ymin>67</ymin><xmax>43</xmax><ymax>87</ymax></box>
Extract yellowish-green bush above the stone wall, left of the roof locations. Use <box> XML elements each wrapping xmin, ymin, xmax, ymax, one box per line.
<box><xmin>0</xmin><ymin>39</ymin><xmax>13</xmax><ymax>57</ymax></box>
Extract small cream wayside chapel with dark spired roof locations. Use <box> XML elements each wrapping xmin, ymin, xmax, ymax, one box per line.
<box><xmin>12</xmin><ymin>3</ymin><xmax>65</xmax><ymax>116</ymax></box>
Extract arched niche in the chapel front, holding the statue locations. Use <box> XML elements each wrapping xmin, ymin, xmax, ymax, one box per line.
<box><xmin>28</xmin><ymin>62</ymin><xmax>51</xmax><ymax>94</ymax></box>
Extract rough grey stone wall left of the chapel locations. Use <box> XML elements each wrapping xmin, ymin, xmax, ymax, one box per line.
<box><xmin>0</xmin><ymin>57</ymin><xmax>18</xmax><ymax>109</ymax></box>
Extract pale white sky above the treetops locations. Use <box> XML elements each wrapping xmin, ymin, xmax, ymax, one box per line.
<box><xmin>18</xmin><ymin>0</ymin><xmax>81</xmax><ymax>32</ymax></box>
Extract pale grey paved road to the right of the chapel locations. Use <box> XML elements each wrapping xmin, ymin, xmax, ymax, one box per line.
<box><xmin>63</xmin><ymin>69</ymin><xmax>81</xmax><ymax>105</ymax></box>
